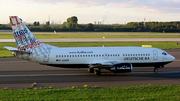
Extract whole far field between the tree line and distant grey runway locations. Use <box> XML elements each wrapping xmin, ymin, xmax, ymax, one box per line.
<box><xmin>0</xmin><ymin>32</ymin><xmax>180</xmax><ymax>39</ymax></box>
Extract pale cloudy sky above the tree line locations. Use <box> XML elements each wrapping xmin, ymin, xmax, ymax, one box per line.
<box><xmin>0</xmin><ymin>0</ymin><xmax>180</xmax><ymax>24</ymax></box>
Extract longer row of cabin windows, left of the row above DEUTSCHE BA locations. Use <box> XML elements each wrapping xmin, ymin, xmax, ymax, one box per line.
<box><xmin>56</xmin><ymin>54</ymin><xmax>120</xmax><ymax>58</ymax></box>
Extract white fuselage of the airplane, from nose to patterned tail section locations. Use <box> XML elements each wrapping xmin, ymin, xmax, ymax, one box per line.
<box><xmin>28</xmin><ymin>47</ymin><xmax>175</xmax><ymax>66</ymax></box>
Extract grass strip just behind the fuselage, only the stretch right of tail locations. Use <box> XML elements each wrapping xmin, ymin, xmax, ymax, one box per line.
<box><xmin>46</xmin><ymin>41</ymin><xmax>180</xmax><ymax>49</ymax></box>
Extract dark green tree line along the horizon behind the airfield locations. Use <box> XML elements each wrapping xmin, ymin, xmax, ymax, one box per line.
<box><xmin>0</xmin><ymin>16</ymin><xmax>180</xmax><ymax>32</ymax></box>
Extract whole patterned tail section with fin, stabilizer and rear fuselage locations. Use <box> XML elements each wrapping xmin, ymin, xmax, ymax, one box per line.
<box><xmin>5</xmin><ymin>16</ymin><xmax>53</xmax><ymax>63</ymax></box>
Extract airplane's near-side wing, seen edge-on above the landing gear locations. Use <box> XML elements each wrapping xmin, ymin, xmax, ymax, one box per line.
<box><xmin>89</xmin><ymin>61</ymin><xmax>121</xmax><ymax>68</ymax></box>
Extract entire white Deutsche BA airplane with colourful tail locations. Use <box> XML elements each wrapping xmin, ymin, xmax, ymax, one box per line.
<box><xmin>4</xmin><ymin>16</ymin><xmax>175</xmax><ymax>75</ymax></box>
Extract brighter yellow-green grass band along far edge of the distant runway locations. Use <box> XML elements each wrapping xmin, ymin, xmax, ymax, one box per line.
<box><xmin>0</xmin><ymin>34</ymin><xmax>180</xmax><ymax>39</ymax></box>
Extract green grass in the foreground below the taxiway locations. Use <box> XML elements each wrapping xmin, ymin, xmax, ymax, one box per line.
<box><xmin>0</xmin><ymin>85</ymin><xmax>180</xmax><ymax>101</ymax></box>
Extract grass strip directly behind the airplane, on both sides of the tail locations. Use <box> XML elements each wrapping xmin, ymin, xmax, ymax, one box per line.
<box><xmin>0</xmin><ymin>41</ymin><xmax>180</xmax><ymax>57</ymax></box>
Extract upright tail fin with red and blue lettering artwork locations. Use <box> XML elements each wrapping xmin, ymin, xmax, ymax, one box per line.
<box><xmin>9</xmin><ymin>16</ymin><xmax>41</xmax><ymax>51</ymax></box>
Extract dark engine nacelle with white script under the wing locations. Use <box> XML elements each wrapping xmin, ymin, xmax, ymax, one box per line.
<box><xmin>110</xmin><ymin>63</ymin><xmax>133</xmax><ymax>73</ymax></box>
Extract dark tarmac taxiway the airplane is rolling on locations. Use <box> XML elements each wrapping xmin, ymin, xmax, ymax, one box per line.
<box><xmin>0</xmin><ymin>49</ymin><xmax>180</xmax><ymax>89</ymax></box>
